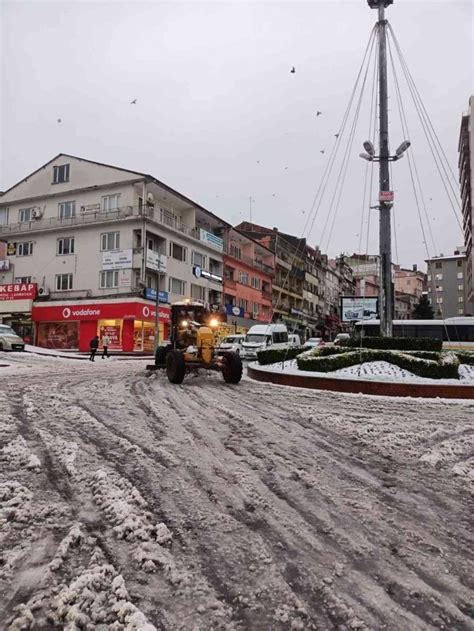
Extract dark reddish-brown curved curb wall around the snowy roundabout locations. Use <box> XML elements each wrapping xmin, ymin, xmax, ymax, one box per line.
<box><xmin>247</xmin><ymin>366</ymin><xmax>474</xmax><ymax>399</ymax></box>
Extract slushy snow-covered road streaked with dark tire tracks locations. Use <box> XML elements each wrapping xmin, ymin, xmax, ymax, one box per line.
<box><xmin>0</xmin><ymin>353</ymin><xmax>474</xmax><ymax>631</ymax></box>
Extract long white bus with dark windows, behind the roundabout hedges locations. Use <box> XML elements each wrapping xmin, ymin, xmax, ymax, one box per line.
<box><xmin>355</xmin><ymin>317</ymin><xmax>474</xmax><ymax>349</ymax></box>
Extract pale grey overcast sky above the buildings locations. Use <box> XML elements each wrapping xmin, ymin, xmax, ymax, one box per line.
<box><xmin>0</xmin><ymin>0</ymin><xmax>474</xmax><ymax>266</ymax></box>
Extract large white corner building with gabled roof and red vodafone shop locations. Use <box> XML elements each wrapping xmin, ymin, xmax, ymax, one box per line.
<box><xmin>0</xmin><ymin>154</ymin><xmax>230</xmax><ymax>351</ymax></box>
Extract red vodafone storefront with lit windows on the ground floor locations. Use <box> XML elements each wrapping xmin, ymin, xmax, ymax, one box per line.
<box><xmin>31</xmin><ymin>298</ymin><xmax>170</xmax><ymax>352</ymax></box>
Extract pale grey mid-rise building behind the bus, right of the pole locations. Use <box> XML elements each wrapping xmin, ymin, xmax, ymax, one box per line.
<box><xmin>426</xmin><ymin>247</ymin><xmax>469</xmax><ymax>318</ymax></box>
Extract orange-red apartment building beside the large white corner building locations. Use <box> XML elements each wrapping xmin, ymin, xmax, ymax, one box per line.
<box><xmin>224</xmin><ymin>228</ymin><xmax>275</xmax><ymax>331</ymax></box>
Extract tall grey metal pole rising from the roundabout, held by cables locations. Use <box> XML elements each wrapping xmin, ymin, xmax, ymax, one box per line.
<box><xmin>377</xmin><ymin>0</ymin><xmax>394</xmax><ymax>337</ymax></box>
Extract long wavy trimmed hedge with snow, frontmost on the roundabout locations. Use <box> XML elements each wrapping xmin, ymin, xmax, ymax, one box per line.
<box><xmin>296</xmin><ymin>349</ymin><xmax>459</xmax><ymax>379</ymax></box>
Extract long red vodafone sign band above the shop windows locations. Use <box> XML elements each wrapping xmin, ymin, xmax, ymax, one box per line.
<box><xmin>31</xmin><ymin>302</ymin><xmax>170</xmax><ymax>322</ymax></box>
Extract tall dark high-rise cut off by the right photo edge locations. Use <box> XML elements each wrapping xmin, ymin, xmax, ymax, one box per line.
<box><xmin>458</xmin><ymin>96</ymin><xmax>474</xmax><ymax>315</ymax></box>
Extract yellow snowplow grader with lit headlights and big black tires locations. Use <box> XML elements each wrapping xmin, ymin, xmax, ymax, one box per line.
<box><xmin>154</xmin><ymin>300</ymin><xmax>242</xmax><ymax>383</ymax></box>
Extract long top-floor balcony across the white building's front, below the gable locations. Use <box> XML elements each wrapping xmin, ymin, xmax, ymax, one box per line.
<box><xmin>0</xmin><ymin>206</ymin><xmax>139</xmax><ymax>236</ymax></box>
